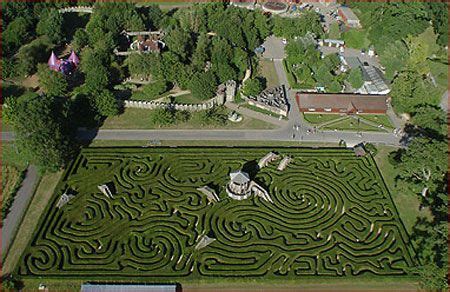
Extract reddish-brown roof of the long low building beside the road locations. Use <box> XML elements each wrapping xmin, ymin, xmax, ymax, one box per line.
<box><xmin>297</xmin><ymin>93</ymin><xmax>387</xmax><ymax>111</ymax></box>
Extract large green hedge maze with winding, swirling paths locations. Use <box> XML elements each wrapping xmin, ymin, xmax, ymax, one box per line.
<box><xmin>18</xmin><ymin>148</ymin><xmax>415</xmax><ymax>279</ymax></box>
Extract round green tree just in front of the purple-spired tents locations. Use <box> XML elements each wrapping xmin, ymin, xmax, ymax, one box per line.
<box><xmin>37</xmin><ymin>64</ymin><xmax>68</xmax><ymax>97</ymax></box>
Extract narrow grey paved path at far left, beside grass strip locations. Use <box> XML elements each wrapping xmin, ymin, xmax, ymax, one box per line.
<box><xmin>2</xmin><ymin>165</ymin><xmax>39</xmax><ymax>256</ymax></box>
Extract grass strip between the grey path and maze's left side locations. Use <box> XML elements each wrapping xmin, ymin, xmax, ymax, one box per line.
<box><xmin>3</xmin><ymin>172</ymin><xmax>62</xmax><ymax>274</ymax></box>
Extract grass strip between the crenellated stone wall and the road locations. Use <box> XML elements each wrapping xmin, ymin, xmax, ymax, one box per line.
<box><xmin>102</xmin><ymin>108</ymin><xmax>274</xmax><ymax>130</ymax></box>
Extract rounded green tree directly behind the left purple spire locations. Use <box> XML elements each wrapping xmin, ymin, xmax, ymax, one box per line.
<box><xmin>36</xmin><ymin>9</ymin><xmax>64</xmax><ymax>44</ymax></box>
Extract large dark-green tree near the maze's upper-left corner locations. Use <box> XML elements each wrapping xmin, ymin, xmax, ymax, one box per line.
<box><xmin>6</xmin><ymin>93</ymin><xmax>73</xmax><ymax>171</ymax></box>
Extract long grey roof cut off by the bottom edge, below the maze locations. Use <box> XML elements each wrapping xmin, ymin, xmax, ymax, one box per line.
<box><xmin>81</xmin><ymin>284</ymin><xmax>177</xmax><ymax>292</ymax></box>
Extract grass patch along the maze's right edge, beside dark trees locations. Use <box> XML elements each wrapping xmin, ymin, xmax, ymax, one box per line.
<box><xmin>375</xmin><ymin>146</ymin><xmax>432</xmax><ymax>234</ymax></box>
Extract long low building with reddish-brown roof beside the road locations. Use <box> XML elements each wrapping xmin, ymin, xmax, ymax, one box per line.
<box><xmin>296</xmin><ymin>93</ymin><xmax>388</xmax><ymax>114</ymax></box>
